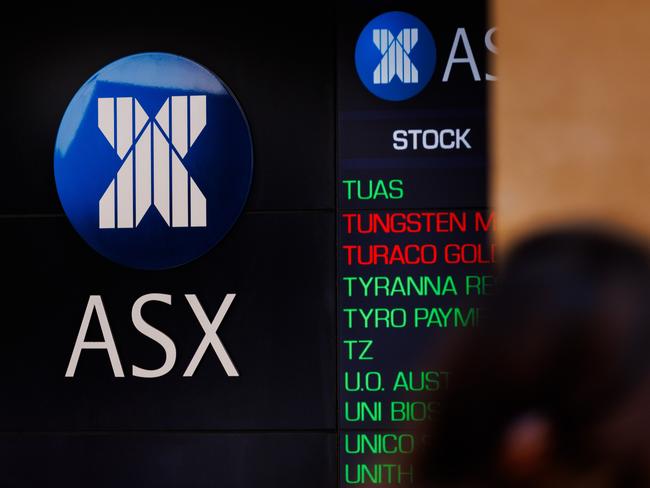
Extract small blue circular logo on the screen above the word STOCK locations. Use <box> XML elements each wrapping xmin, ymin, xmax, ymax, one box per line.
<box><xmin>354</xmin><ymin>12</ymin><xmax>436</xmax><ymax>101</ymax></box>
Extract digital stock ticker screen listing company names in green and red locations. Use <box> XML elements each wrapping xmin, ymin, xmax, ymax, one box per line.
<box><xmin>337</xmin><ymin>4</ymin><xmax>495</xmax><ymax>486</ymax></box>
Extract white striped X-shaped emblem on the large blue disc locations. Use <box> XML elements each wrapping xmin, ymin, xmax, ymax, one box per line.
<box><xmin>97</xmin><ymin>95</ymin><xmax>207</xmax><ymax>229</ymax></box>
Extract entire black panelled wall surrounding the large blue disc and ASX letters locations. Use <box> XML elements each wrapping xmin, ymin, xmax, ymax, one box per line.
<box><xmin>0</xmin><ymin>3</ymin><xmax>336</xmax><ymax>487</ymax></box>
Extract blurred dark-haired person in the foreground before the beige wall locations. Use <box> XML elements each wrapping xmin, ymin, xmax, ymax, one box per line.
<box><xmin>416</xmin><ymin>228</ymin><xmax>650</xmax><ymax>488</ymax></box>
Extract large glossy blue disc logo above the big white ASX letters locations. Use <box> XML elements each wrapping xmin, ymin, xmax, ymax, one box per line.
<box><xmin>54</xmin><ymin>53</ymin><xmax>253</xmax><ymax>269</ymax></box>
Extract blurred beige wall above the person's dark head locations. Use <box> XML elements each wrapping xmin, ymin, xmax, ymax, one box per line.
<box><xmin>491</xmin><ymin>0</ymin><xmax>650</xmax><ymax>252</ymax></box>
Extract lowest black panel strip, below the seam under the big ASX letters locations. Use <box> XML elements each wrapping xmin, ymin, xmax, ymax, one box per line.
<box><xmin>0</xmin><ymin>433</ymin><xmax>336</xmax><ymax>488</ymax></box>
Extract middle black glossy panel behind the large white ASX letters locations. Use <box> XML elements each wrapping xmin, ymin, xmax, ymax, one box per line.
<box><xmin>0</xmin><ymin>213</ymin><xmax>336</xmax><ymax>431</ymax></box>
